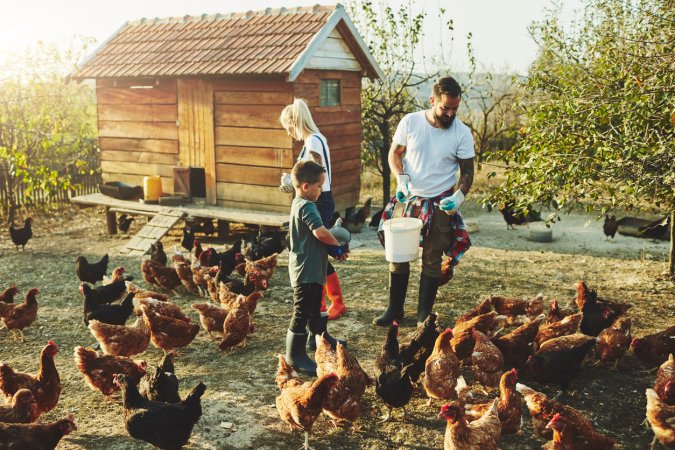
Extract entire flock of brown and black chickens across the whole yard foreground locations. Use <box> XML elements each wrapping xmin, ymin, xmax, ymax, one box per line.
<box><xmin>0</xmin><ymin>214</ymin><xmax>675</xmax><ymax>450</ymax></box>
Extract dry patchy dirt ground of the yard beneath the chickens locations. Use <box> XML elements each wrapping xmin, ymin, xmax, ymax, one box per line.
<box><xmin>0</xmin><ymin>205</ymin><xmax>675</xmax><ymax>450</ymax></box>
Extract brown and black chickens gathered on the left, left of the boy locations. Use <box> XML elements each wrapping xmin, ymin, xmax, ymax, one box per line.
<box><xmin>0</xmin><ymin>227</ymin><xmax>285</xmax><ymax>450</ymax></box>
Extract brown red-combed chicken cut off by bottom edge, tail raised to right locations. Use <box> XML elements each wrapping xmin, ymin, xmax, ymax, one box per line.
<box><xmin>439</xmin><ymin>399</ymin><xmax>502</xmax><ymax>450</ymax></box>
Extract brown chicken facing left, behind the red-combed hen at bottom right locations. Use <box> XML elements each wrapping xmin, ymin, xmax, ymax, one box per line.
<box><xmin>516</xmin><ymin>383</ymin><xmax>614</xmax><ymax>450</ymax></box>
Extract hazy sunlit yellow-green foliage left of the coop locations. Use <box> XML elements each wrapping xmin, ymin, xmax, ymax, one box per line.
<box><xmin>0</xmin><ymin>40</ymin><xmax>96</xmax><ymax>216</ymax></box>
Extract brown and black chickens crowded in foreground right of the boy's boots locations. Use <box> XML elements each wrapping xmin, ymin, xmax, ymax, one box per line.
<box><xmin>276</xmin><ymin>281</ymin><xmax>675</xmax><ymax>450</ymax></box>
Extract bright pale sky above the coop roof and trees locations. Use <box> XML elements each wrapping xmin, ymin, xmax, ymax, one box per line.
<box><xmin>0</xmin><ymin>0</ymin><xmax>582</xmax><ymax>74</ymax></box>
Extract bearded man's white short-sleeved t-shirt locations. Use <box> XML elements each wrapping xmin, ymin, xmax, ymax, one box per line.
<box><xmin>393</xmin><ymin>111</ymin><xmax>476</xmax><ymax>198</ymax></box>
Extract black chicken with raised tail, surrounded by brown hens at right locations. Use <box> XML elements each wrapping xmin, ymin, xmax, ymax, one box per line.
<box><xmin>525</xmin><ymin>340</ymin><xmax>595</xmax><ymax>400</ymax></box>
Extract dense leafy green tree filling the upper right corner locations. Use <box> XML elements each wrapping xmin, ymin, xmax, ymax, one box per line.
<box><xmin>488</xmin><ymin>0</ymin><xmax>675</xmax><ymax>218</ymax></box>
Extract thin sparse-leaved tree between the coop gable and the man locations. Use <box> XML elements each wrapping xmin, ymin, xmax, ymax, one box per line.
<box><xmin>347</xmin><ymin>0</ymin><xmax>452</xmax><ymax>203</ymax></box>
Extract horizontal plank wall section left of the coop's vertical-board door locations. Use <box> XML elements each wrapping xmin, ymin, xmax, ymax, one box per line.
<box><xmin>96</xmin><ymin>79</ymin><xmax>178</xmax><ymax>193</ymax></box>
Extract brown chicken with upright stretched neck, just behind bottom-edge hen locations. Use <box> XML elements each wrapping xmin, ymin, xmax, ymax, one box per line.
<box><xmin>464</xmin><ymin>369</ymin><xmax>523</xmax><ymax>434</ymax></box>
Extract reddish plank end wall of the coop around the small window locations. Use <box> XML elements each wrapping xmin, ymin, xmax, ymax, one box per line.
<box><xmin>293</xmin><ymin>70</ymin><xmax>361</xmax><ymax>212</ymax></box>
